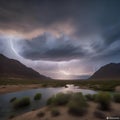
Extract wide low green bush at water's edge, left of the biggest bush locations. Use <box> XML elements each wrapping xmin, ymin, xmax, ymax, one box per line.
<box><xmin>47</xmin><ymin>93</ymin><xmax>71</xmax><ymax>105</ymax></box>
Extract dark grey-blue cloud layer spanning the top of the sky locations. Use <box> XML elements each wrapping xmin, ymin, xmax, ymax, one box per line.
<box><xmin>0</xmin><ymin>0</ymin><xmax>120</xmax><ymax>35</ymax></box>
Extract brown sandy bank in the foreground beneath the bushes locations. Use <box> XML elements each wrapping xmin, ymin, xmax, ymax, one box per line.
<box><xmin>12</xmin><ymin>102</ymin><xmax>120</xmax><ymax>120</ymax></box>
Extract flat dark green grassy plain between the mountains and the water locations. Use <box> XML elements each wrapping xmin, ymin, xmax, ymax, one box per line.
<box><xmin>0</xmin><ymin>78</ymin><xmax>120</xmax><ymax>91</ymax></box>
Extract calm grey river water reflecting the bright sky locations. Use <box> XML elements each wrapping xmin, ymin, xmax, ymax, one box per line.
<box><xmin>0</xmin><ymin>85</ymin><xmax>96</xmax><ymax>120</ymax></box>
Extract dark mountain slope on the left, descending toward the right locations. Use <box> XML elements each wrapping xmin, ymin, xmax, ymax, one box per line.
<box><xmin>0</xmin><ymin>54</ymin><xmax>48</xmax><ymax>79</ymax></box>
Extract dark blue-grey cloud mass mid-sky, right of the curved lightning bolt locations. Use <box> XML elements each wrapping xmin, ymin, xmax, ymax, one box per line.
<box><xmin>13</xmin><ymin>33</ymin><xmax>86</xmax><ymax>61</ymax></box>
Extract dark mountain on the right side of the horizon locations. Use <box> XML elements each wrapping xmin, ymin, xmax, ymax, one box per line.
<box><xmin>90</xmin><ymin>63</ymin><xmax>120</xmax><ymax>79</ymax></box>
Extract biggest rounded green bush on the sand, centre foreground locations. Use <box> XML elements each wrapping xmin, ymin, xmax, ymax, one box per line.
<box><xmin>68</xmin><ymin>93</ymin><xmax>88</xmax><ymax>116</ymax></box>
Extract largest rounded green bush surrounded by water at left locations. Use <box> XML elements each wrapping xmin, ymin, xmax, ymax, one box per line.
<box><xmin>13</xmin><ymin>97</ymin><xmax>30</xmax><ymax>109</ymax></box>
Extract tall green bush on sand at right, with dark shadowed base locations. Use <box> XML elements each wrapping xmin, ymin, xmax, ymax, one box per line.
<box><xmin>96</xmin><ymin>92</ymin><xmax>111</xmax><ymax>110</ymax></box>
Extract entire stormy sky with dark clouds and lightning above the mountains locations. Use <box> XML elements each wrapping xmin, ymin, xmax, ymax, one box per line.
<box><xmin>0</xmin><ymin>0</ymin><xmax>120</xmax><ymax>79</ymax></box>
